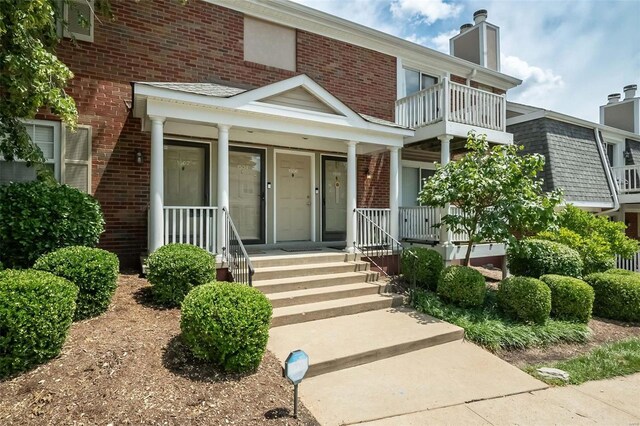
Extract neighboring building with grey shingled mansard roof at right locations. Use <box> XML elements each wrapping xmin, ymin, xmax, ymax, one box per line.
<box><xmin>507</xmin><ymin>85</ymin><xmax>640</xmax><ymax>238</ymax></box>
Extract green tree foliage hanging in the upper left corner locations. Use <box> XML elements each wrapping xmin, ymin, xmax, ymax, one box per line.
<box><xmin>0</xmin><ymin>0</ymin><xmax>78</xmax><ymax>171</ymax></box>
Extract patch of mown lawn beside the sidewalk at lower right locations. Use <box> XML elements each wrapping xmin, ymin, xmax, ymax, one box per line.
<box><xmin>523</xmin><ymin>337</ymin><xmax>640</xmax><ymax>386</ymax></box>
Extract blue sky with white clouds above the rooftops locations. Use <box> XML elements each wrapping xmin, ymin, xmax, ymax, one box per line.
<box><xmin>294</xmin><ymin>0</ymin><xmax>640</xmax><ymax>122</ymax></box>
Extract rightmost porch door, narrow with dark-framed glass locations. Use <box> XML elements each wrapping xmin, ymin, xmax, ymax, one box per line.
<box><xmin>322</xmin><ymin>156</ymin><xmax>347</xmax><ymax>241</ymax></box>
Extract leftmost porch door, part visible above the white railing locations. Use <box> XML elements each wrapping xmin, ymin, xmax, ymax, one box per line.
<box><xmin>164</xmin><ymin>144</ymin><xmax>207</xmax><ymax>206</ymax></box>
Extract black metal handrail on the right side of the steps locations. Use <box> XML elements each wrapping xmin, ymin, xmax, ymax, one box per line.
<box><xmin>353</xmin><ymin>209</ymin><xmax>418</xmax><ymax>288</ymax></box>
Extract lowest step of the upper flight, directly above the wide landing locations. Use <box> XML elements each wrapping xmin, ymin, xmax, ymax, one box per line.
<box><xmin>271</xmin><ymin>294</ymin><xmax>403</xmax><ymax>327</ymax></box>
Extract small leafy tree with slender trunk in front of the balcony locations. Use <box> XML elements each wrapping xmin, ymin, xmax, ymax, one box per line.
<box><xmin>419</xmin><ymin>132</ymin><xmax>562</xmax><ymax>265</ymax></box>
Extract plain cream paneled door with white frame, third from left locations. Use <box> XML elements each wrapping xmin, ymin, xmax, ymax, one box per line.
<box><xmin>276</xmin><ymin>153</ymin><xmax>312</xmax><ymax>241</ymax></box>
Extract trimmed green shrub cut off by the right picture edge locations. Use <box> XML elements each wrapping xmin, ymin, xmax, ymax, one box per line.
<box><xmin>585</xmin><ymin>272</ymin><xmax>640</xmax><ymax>322</ymax></box>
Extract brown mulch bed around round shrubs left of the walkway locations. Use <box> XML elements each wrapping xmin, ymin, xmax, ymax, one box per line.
<box><xmin>0</xmin><ymin>274</ymin><xmax>317</xmax><ymax>425</ymax></box>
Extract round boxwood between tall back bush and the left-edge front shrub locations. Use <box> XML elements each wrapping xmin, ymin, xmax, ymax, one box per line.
<box><xmin>34</xmin><ymin>246</ymin><xmax>119</xmax><ymax>321</ymax></box>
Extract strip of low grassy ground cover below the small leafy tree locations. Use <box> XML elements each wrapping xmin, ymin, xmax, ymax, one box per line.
<box><xmin>413</xmin><ymin>290</ymin><xmax>591</xmax><ymax>352</ymax></box>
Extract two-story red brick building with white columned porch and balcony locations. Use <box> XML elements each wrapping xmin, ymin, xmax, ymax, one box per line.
<box><xmin>0</xmin><ymin>0</ymin><xmax>521</xmax><ymax>266</ymax></box>
